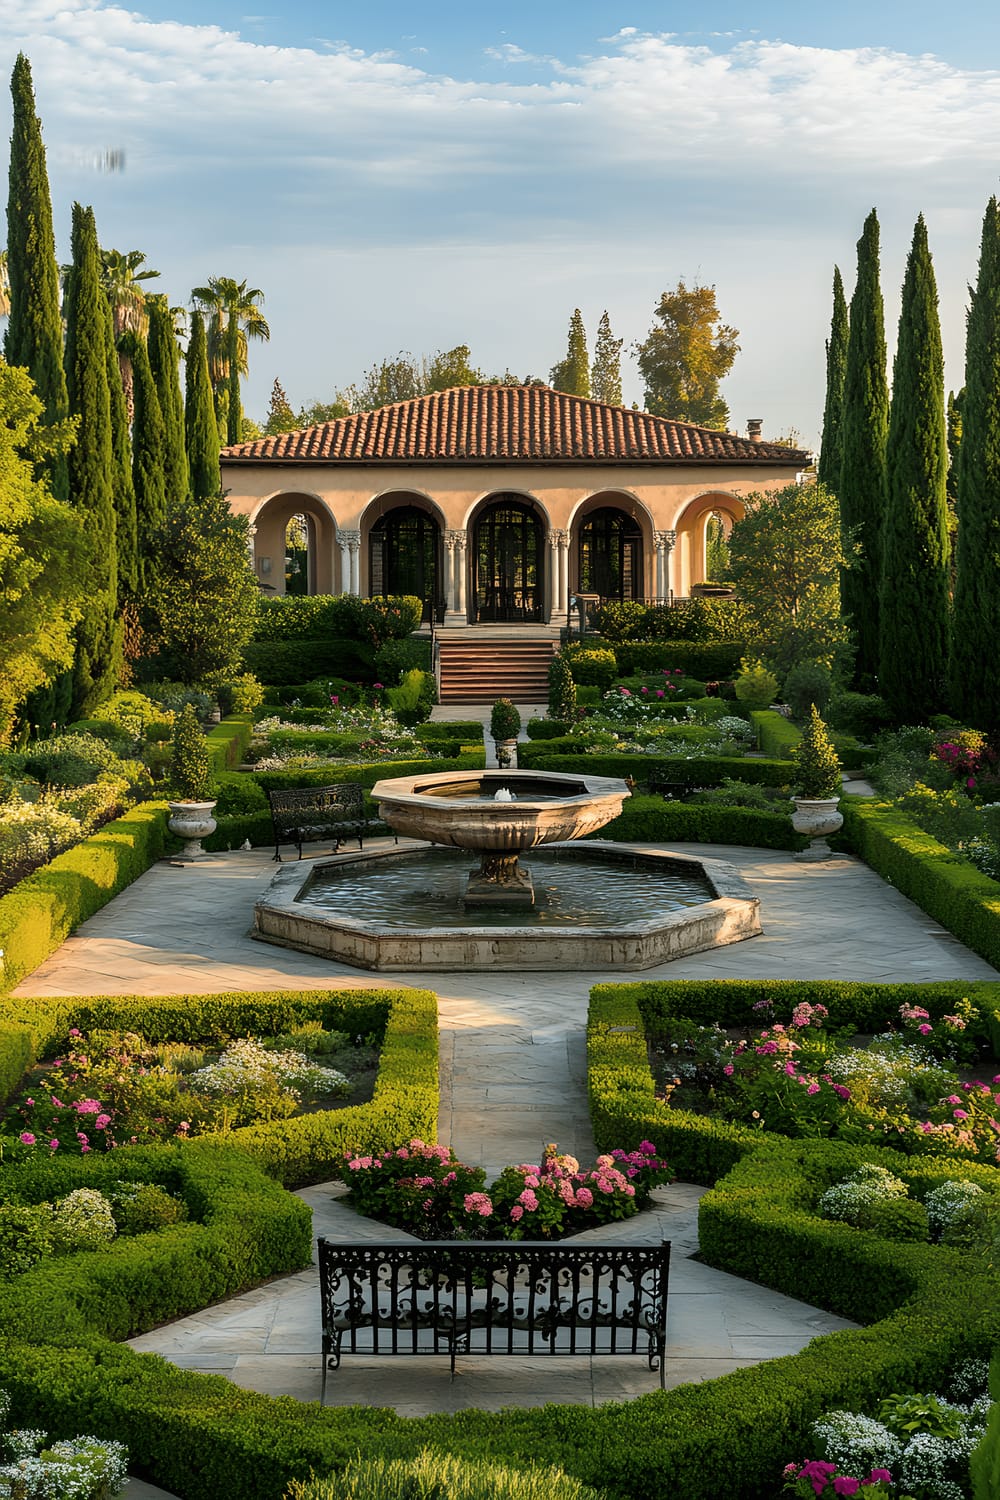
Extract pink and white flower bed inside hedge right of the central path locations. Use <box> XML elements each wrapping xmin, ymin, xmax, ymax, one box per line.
<box><xmin>649</xmin><ymin>999</ymin><xmax>1000</xmax><ymax>1164</ymax></box>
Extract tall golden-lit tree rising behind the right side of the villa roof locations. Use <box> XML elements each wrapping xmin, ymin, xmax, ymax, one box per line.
<box><xmin>636</xmin><ymin>281</ymin><xmax>739</xmax><ymax>429</ymax></box>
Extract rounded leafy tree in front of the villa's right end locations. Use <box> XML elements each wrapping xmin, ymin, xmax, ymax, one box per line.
<box><xmin>729</xmin><ymin>485</ymin><xmax>849</xmax><ymax>678</ymax></box>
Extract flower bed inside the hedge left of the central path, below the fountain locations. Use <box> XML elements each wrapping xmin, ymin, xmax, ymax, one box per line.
<box><xmin>0</xmin><ymin>1022</ymin><xmax>378</xmax><ymax>1161</ymax></box>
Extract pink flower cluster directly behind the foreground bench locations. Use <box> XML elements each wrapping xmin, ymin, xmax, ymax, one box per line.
<box><xmin>343</xmin><ymin>1140</ymin><xmax>672</xmax><ymax>1239</ymax></box>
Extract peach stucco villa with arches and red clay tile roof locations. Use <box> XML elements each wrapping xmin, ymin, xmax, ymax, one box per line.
<box><xmin>222</xmin><ymin>386</ymin><xmax>810</xmax><ymax>687</ymax></box>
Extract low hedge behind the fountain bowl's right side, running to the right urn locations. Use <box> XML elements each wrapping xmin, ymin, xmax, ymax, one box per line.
<box><xmin>589</xmin><ymin>792</ymin><xmax>808</xmax><ymax>849</ymax></box>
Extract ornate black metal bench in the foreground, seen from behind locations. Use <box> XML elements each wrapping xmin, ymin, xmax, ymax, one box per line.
<box><xmin>319</xmin><ymin>1239</ymin><xmax>670</xmax><ymax>1401</ymax></box>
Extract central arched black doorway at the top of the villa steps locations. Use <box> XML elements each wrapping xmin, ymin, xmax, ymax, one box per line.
<box><xmin>472</xmin><ymin>495</ymin><xmax>544</xmax><ymax>624</ymax></box>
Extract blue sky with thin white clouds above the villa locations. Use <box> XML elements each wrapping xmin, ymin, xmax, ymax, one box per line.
<box><xmin>0</xmin><ymin>0</ymin><xmax>1000</xmax><ymax>446</ymax></box>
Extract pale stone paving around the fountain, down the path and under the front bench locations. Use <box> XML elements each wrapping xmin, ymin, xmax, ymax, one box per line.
<box><xmin>15</xmin><ymin>845</ymin><xmax>999</xmax><ymax>1500</ymax></box>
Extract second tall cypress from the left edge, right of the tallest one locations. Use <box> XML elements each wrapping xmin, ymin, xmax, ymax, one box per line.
<box><xmin>66</xmin><ymin>203</ymin><xmax>123</xmax><ymax>719</ymax></box>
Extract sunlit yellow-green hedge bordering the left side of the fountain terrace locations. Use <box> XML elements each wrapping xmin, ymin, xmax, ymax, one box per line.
<box><xmin>0</xmin><ymin>803</ymin><xmax>169</xmax><ymax>992</ymax></box>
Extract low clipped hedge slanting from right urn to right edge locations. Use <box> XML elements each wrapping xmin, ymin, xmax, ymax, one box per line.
<box><xmin>840</xmin><ymin>798</ymin><xmax>1000</xmax><ymax>968</ymax></box>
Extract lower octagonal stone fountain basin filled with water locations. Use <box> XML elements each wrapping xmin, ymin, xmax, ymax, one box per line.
<box><xmin>253</xmin><ymin>842</ymin><xmax>760</xmax><ymax>974</ymax></box>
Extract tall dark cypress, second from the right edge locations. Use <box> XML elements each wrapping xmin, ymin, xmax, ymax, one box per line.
<box><xmin>879</xmin><ymin>215</ymin><xmax>951</xmax><ymax>723</ymax></box>
